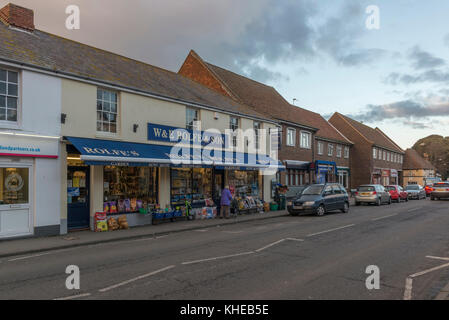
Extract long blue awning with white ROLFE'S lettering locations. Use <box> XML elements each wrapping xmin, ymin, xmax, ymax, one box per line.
<box><xmin>66</xmin><ymin>137</ymin><xmax>284</xmax><ymax>170</ymax></box>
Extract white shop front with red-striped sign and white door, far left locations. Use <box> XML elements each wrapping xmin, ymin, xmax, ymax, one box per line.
<box><xmin>0</xmin><ymin>134</ymin><xmax>60</xmax><ymax>238</ymax></box>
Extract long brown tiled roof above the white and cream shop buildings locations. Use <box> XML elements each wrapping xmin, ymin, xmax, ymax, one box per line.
<box><xmin>0</xmin><ymin>22</ymin><xmax>272</xmax><ymax>119</ymax></box>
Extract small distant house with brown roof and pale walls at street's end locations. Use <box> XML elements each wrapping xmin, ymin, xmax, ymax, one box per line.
<box><xmin>402</xmin><ymin>149</ymin><xmax>436</xmax><ymax>186</ymax></box>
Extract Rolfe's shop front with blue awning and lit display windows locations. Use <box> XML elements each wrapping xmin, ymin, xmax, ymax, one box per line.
<box><xmin>67</xmin><ymin>137</ymin><xmax>282</xmax><ymax>228</ymax></box>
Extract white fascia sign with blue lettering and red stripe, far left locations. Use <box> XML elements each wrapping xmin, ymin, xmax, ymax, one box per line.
<box><xmin>0</xmin><ymin>135</ymin><xmax>59</xmax><ymax>158</ymax></box>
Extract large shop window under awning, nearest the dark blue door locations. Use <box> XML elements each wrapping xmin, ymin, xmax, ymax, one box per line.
<box><xmin>104</xmin><ymin>166</ymin><xmax>158</xmax><ymax>213</ymax></box>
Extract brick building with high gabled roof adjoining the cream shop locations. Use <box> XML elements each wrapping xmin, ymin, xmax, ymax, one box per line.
<box><xmin>179</xmin><ymin>50</ymin><xmax>319</xmax><ymax>185</ymax></box>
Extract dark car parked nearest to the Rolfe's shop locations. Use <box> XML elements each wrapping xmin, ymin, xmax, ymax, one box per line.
<box><xmin>287</xmin><ymin>183</ymin><xmax>349</xmax><ymax>216</ymax></box>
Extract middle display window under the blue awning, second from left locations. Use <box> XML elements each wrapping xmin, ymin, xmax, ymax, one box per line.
<box><xmin>171</xmin><ymin>168</ymin><xmax>212</xmax><ymax>206</ymax></box>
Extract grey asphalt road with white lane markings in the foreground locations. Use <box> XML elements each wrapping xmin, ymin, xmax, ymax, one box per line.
<box><xmin>0</xmin><ymin>200</ymin><xmax>449</xmax><ymax>299</ymax></box>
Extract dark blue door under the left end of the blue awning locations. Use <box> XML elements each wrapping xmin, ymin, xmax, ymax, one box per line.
<box><xmin>67</xmin><ymin>167</ymin><xmax>90</xmax><ymax>230</ymax></box>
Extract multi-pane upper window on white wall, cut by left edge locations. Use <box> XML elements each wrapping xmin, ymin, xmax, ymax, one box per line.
<box><xmin>0</xmin><ymin>69</ymin><xmax>19</xmax><ymax>122</ymax></box>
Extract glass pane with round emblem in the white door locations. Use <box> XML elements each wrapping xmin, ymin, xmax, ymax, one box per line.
<box><xmin>0</xmin><ymin>168</ymin><xmax>29</xmax><ymax>205</ymax></box>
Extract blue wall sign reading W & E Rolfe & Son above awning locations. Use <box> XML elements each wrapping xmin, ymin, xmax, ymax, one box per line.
<box><xmin>148</xmin><ymin>123</ymin><xmax>226</xmax><ymax>148</ymax></box>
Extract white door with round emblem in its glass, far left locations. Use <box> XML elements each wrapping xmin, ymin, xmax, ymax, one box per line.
<box><xmin>0</xmin><ymin>165</ymin><xmax>33</xmax><ymax>238</ymax></box>
